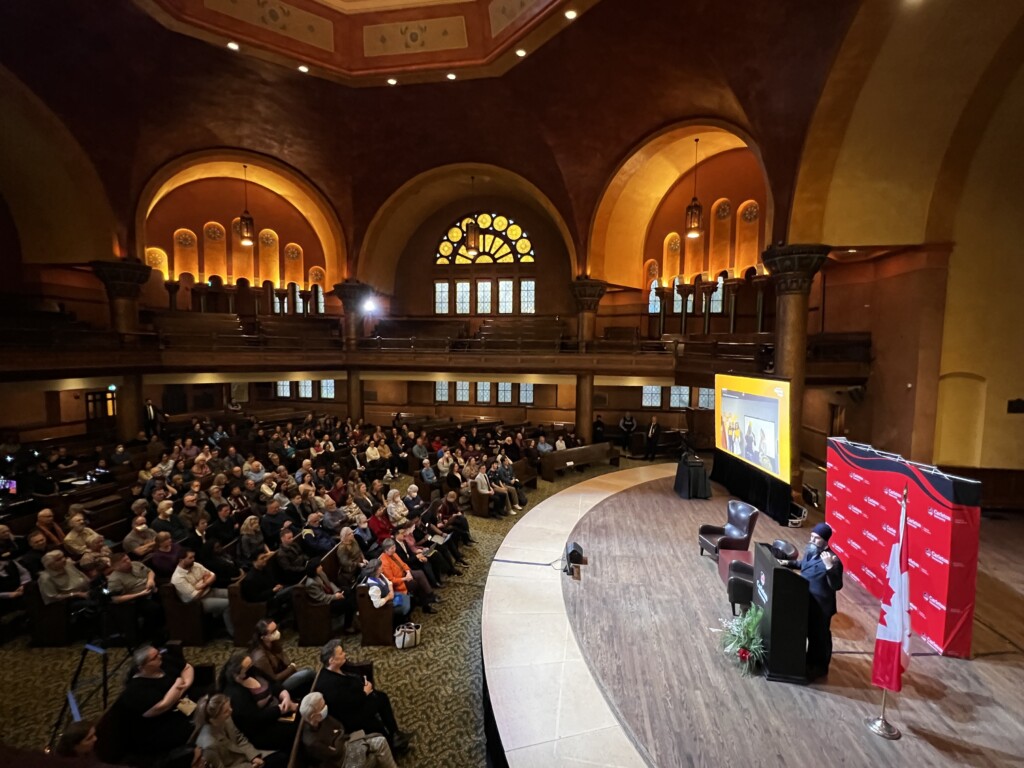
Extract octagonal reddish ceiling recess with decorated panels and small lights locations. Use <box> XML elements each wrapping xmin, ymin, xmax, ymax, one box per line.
<box><xmin>135</xmin><ymin>0</ymin><xmax>599</xmax><ymax>86</ymax></box>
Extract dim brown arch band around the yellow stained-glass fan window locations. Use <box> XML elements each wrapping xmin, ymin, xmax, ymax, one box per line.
<box><xmin>352</xmin><ymin>163</ymin><xmax>578</xmax><ymax>294</ymax></box>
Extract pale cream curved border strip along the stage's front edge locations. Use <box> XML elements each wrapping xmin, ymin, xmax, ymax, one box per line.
<box><xmin>481</xmin><ymin>464</ymin><xmax>676</xmax><ymax>768</ymax></box>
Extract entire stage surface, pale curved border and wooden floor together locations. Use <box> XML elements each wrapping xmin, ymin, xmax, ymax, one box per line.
<box><xmin>481</xmin><ymin>464</ymin><xmax>1024</xmax><ymax>768</ymax></box>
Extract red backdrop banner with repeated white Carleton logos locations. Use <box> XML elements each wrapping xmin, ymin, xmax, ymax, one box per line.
<box><xmin>825</xmin><ymin>437</ymin><xmax>981</xmax><ymax>658</ymax></box>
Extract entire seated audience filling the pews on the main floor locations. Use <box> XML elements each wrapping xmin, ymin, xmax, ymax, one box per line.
<box><xmin>0</xmin><ymin>415</ymin><xmax>581</xmax><ymax>766</ymax></box>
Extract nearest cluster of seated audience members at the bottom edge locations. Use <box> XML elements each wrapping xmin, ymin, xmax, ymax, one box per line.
<box><xmin>56</xmin><ymin>638</ymin><xmax>414</xmax><ymax>768</ymax></box>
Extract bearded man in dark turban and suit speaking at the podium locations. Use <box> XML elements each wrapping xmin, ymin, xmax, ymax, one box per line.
<box><xmin>782</xmin><ymin>522</ymin><xmax>843</xmax><ymax>680</ymax></box>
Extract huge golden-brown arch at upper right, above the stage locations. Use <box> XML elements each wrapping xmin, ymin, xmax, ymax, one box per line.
<box><xmin>790</xmin><ymin>0</ymin><xmax>1024</xmax><ymax>246</ymax></box>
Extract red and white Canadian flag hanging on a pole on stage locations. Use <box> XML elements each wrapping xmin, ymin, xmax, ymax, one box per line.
<box><xmin>871</xmin><ymin>485</ymin><xmax>910</xmax><ymax>691</ymax></box>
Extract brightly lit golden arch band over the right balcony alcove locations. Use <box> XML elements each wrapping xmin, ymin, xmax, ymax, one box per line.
<box><xmin>587</xmin><ymin>120</ymin><xmax>772</xmax><ymax>288</ymax></box>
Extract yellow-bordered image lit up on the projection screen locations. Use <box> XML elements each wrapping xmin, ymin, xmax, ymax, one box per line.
<box><xmin>715</xmin><ymin>375</ymin><xmax>790</xmax><ymax>482</ymax></box>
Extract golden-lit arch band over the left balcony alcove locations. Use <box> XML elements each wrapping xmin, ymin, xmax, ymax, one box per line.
<box><xmin>134</xmin><ymin>148</ymin><xmax>348</xmax><ymax>290</ymax></box>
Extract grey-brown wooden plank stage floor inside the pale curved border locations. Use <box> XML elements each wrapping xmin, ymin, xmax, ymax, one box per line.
<box><xmin>560</xmin><ymin>477</ymin><xmax>1024</xmax><ymax>768</ymax></box>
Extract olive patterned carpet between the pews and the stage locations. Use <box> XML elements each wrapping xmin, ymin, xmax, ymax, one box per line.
<box><xmin>0</xmin><ymin>459</ymin><xmax>663</xmax><ymax>768</ymax></box>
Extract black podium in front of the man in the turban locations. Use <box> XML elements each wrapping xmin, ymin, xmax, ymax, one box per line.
<box><xmin>754</xmin><ymin>544</ymin><xmax>809</xmax><ymax>684</ymax></box>
